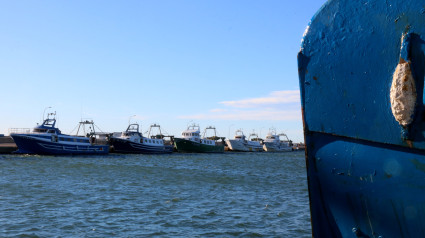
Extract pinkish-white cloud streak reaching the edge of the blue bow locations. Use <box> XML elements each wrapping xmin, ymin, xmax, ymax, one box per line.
<box><xmin>220</xmin><ymin>90</ymin><xmax>300</xmax><ymax>108</ymax></box>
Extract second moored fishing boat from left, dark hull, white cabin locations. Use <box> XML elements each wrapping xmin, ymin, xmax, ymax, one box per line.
<box><xmin>110</xmin><ymin>123</ymin><xmax>173</xmax><ymax>154</ymax></box>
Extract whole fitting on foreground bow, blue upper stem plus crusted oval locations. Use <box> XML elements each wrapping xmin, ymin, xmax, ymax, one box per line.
<box><xmin>390</xmin><ymin>33</ymin><xmax>417</xmax><ymax>134</ymax></box>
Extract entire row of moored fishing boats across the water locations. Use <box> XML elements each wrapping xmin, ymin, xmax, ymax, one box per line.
<box><xmin>4</xmin><ymin>112</ymin><xmax>291</xmax><ymax>155</ymax></box>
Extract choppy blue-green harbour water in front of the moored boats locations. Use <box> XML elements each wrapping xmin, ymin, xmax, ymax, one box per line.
<box><xmin>0</xmin><ymin>152</ymin><xmax>311</xmax><ymax>237</ymax></box>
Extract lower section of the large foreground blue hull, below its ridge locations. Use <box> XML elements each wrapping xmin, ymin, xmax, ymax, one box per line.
<box><xmin>307</xmin><ymin>133</ymin><xmax>425</xmax><ymax>237</ymax></box>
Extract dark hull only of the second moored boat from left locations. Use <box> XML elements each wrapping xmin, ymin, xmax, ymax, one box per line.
<box><xmin>110</xmin><ymin>138</ymin><xmax>174</xmax><ymax>154</ymax></box>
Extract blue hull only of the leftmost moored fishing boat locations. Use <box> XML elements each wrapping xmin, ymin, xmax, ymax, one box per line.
<box><xmin>11</xmin><ymin>135</ymin><xmax>109</xmax><ymax>155</ymax></box>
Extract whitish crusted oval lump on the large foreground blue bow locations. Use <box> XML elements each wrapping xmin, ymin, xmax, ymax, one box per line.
<box><xmin>390</xmin><ymin>60</ymin><xmax>416</xmax><ymax>126</ymax></box>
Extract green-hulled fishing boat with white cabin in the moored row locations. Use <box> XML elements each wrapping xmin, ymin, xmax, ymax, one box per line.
<box><xmin>174</xmin><ymin>124</ymin><xmax>224</xmax><ymax>153</ymax></box>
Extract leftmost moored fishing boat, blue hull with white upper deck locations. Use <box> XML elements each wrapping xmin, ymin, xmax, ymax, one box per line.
<box><xmin>9</xmin><ymin>112</ymin><xmax>109</xmax><ymax>155</ymax></box>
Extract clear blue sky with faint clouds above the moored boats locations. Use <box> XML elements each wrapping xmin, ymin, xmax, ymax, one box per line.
<box><xmin>0</xmin><ymin>0</ymin><xmax>326</xmax><ymax>142</ymax></box>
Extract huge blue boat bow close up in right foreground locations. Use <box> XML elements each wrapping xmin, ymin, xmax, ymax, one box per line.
<box><xmin>298</xmin><ymin>0</ymin><xmax>425</xmax><ymax>238</ymax></box>
